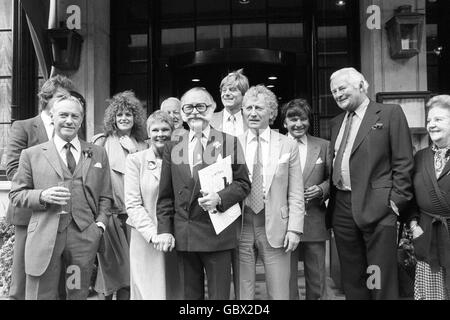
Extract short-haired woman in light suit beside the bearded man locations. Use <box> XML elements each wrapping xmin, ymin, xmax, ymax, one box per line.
<box><xmin>125</xmin><ymin>110</ymin><xmax>182</xmax><ymax>300</ymax></box>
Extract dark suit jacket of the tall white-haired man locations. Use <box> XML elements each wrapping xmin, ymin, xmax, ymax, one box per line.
<box><xmin>327</xmin><ymin>102</ymin><xmax>414</xmax><ymax>229</ymax></box>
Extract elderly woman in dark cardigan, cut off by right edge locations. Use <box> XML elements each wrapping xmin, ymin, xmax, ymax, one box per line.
<box><xmin>409</xmin><ymin>95</ymin><xmax>450</xmax><ymax>300</ymax></box>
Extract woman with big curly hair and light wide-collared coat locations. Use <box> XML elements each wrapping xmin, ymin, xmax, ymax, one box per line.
<box><xmin>92</xmin><ymin>91</ymin><xmax>148</xmax><ymax>300</ymax></box>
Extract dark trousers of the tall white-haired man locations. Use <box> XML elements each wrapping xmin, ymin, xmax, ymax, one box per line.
<box><xmin>332</xmin><ymin>191</ymin><xmax>398</xmax><ymax>300</ymax></box>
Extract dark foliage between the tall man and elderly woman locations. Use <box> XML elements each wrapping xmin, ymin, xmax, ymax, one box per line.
<box><xmin>397</xmin><ymin>223</ymin><xmax>417</xmax><ymax>298</ymax></box>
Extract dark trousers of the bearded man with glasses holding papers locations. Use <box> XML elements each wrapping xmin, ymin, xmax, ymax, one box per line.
<box><xmin>177</xmin><ymin>249</ymin><xmax>233</xmax><ymax>300</ymax></box>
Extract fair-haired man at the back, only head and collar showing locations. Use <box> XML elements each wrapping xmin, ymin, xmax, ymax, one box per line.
<box><xmin>211</xmin><ymin>69</ymin><xmax>249</xmax><ymax>137</ymax></box>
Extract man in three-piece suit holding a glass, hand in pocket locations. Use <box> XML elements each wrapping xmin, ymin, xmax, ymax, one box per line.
<box><xmin>10</xmin><ymin>95</ymin><xmax>112</xmax><ymax>300</ymax></box>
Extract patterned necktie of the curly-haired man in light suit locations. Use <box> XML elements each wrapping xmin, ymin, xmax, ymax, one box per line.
<box><xmin>248</xmin><ymin>135</ymin><xmax>264</xmax><ymax>214</ymax></box>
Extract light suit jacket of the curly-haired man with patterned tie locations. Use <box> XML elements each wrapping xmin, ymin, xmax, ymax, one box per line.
<box><xmin>239</xmin><ymin>130</ymin><xmax>305</xmax><ymax>248</ymax></box>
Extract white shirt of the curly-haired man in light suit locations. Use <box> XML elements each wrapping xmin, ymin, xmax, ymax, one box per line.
<box><xmin>245</xmin><ymin>128</ymin><xmax>270</xmax><ymax>190</ymax></box>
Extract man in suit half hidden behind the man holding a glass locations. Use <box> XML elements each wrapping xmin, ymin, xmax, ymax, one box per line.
<box><xmin>6</xmin><ymin>75</ymin><xmax>73</xmax><ymax>300</ymax></box>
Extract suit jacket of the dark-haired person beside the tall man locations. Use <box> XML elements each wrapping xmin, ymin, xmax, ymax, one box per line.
<box><xmin>302</xmin><ymin>135</ymin><xmax>331</xmax><ymax>242</ymax></box>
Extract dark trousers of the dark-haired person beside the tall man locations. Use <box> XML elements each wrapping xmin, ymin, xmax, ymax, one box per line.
<box><xmin>289</xmin><ymin>241</ymin><xmax>328</xmax><ymax>300</ymax></box>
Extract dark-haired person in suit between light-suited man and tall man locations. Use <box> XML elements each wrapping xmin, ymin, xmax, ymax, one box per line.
<box><xmin>281</xmin><ymin>99</ymin><xmax>330</xmax><ymax>300</ymax></box>
